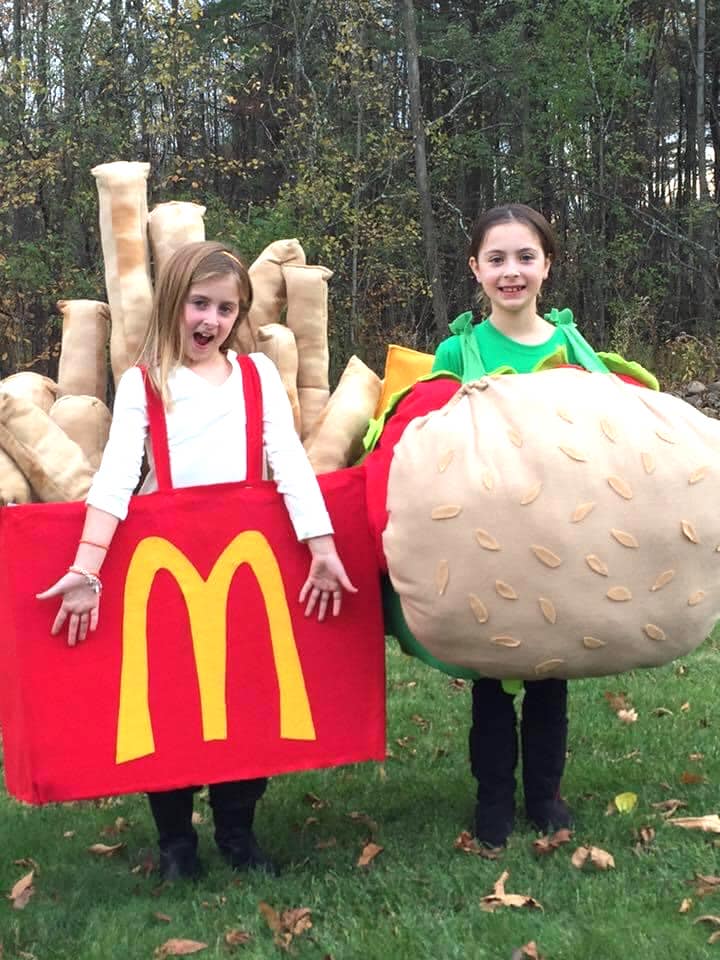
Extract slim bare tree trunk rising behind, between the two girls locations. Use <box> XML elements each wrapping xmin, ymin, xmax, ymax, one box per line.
<box><xmin>401</xmin><ymin>0</ymin><xmax>448</xmax><ymax>336</ymax></box>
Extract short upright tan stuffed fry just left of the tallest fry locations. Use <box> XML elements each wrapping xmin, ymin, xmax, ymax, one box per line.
<box><xmin>57</xmin><ymin>300</ymin><xmax>110</xmax><ymax>400</ymax></box>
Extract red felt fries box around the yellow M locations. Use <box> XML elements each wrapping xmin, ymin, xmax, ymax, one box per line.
<box><xmin>0</xmin><ymin>468</ymin><xmax>385</xmax><ymax>803</ymax></box>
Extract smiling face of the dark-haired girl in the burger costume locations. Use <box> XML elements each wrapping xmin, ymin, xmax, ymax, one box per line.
<box><xmin>469</xmin><ymin>220</ymin><xmax>550</xmax><ymax>315</ymax></box>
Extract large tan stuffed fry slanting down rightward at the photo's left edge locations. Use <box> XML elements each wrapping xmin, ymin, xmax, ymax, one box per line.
<box><xmin>0</xmin><ymin>393</ymin><xmax>94</xmax><ymax>501</ymax></box>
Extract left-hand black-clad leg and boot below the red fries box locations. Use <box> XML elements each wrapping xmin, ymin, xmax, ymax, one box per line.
<box><xmin>148</xmin><ymin>787</ymin><xmax>202</xmax><ymax>883</ymax></box>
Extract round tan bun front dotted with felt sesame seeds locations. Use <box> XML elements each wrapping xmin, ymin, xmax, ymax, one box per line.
<box><xmin>383</xmin><ymin>369</ymin><xmax>720</xmax><ymax>679</ymax></box>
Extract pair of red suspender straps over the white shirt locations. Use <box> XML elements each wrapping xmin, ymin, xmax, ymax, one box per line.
<box><xmin>140</xmin><ymin>357</ymin><xmax>263</xmax><ymax>490</ymax></box>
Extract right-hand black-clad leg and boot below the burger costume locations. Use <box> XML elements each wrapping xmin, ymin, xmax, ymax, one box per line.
<box><xmin>521</xmin><ymin>680</ymin><xmax>572</xmax><ymax>833</ymax></box>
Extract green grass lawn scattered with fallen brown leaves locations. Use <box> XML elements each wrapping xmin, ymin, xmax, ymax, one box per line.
<box><xmin>0</xmin><ymin>634</ymin><xmax>720</xmax><ymax>960</ymax></box>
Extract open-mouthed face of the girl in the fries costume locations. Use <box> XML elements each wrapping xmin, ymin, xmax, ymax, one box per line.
<box><xmin>182</xmin><ymin>274</ymin><xmax>240</xmax><ymax>367</ymax></box>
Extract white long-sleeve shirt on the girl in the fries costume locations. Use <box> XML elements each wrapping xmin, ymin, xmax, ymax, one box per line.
<box><xmin>87</xmin><ymin>350</ymin><xmax>333</xmax><ymax>540</ymax></box>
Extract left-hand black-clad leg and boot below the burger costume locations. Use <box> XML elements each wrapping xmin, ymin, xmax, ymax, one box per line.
<box><xmin>470</xmin><ymin>677</ymin><xmax>518</xmax><ymax>847</ymax></box>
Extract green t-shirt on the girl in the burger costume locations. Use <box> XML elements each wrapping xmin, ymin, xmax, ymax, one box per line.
<box><xmin>433</xmin><ymin>319</ymin><xmax>578</xmax><ymax>379</ymax></box>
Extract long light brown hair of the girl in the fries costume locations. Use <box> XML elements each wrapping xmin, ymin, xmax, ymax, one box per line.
<box><xmin>138</xmin><ymin>240</ymin><xmax>252</xmax><ymax>406</ymax></box>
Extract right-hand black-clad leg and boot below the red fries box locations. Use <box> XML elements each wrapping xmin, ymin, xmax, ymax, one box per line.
<box><xmin>210</xmin><ymin>777</ymin><xmax>278</xmax><ymax>874</ymax></box>
